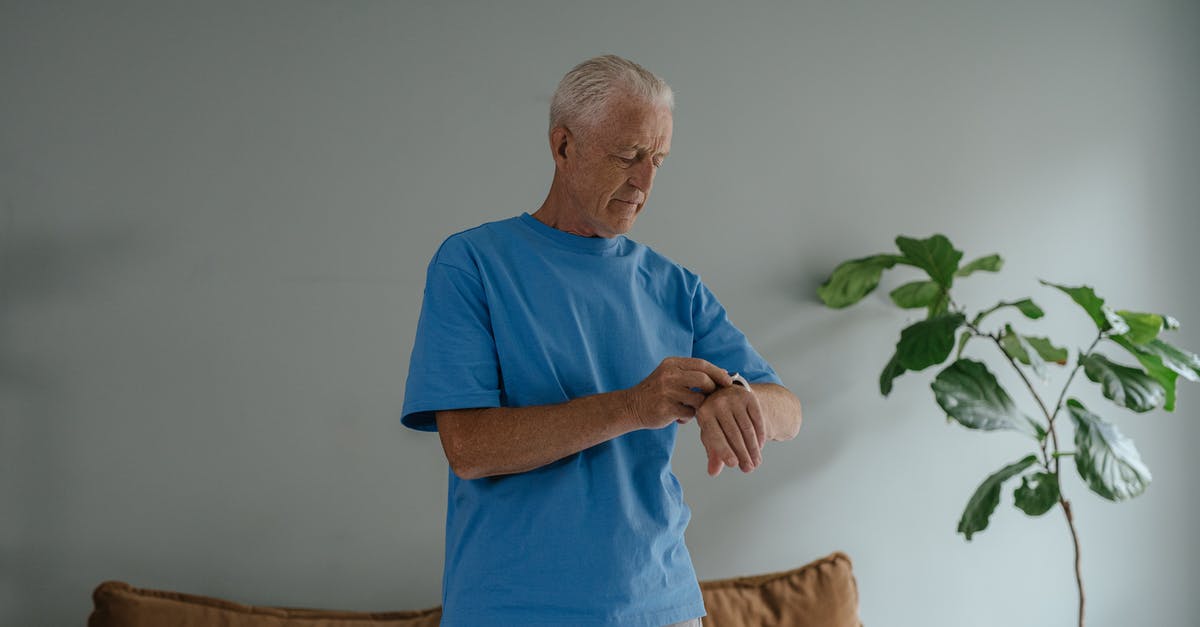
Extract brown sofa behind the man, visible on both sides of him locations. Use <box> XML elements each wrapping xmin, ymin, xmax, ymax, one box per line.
<box><xmin>88</xmin><ymin>553</ymin><xmax>862</xmax><ymax>627</ymax></box>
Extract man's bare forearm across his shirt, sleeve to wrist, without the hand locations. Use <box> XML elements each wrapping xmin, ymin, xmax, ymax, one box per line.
<box><xmin>437</xmin><ymin>390</ymin><xmax>641</xmax><ymax>479</ymax></box>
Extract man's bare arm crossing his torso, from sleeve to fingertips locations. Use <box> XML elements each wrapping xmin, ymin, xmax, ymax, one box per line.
<box><xmin>436</xmin><ymin>357</ymin><xmax>731</xmax><ymax>479</ymax></box>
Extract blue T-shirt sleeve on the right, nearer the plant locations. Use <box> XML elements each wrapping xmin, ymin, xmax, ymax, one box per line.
<box><xmin>691</xmin><ymin>282</ymin><xmax>784</xmax><ymax>386</ymax></box>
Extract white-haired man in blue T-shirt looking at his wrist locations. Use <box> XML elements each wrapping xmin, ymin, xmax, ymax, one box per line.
<box><xmin>402</xmin><ymin>55</ymin><xmax>800</xmax><ymax>627</ymax></box>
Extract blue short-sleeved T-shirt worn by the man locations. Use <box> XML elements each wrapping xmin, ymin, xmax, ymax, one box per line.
<box><xmin>402</xmin><ymin>214</ymin><xmax>780</xmax><ymax>627</ymax></box>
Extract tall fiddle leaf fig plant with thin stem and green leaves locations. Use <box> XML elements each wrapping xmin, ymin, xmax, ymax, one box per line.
<box><xmin>817</xmin><ymin>234</ymin><xmax>1200</xmax><ymax>627</ymax></box>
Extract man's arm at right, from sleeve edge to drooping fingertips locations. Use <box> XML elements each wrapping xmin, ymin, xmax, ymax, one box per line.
<box><xmin>696</xmin><ymin>383</ymin><xmax>802</xmax><ymax>477</ymax></box>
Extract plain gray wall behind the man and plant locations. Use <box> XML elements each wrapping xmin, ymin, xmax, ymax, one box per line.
<box><xmin>0</xmin><ymin>0</ymin><xmax>1200</xmax><ymax>627</ymax></box>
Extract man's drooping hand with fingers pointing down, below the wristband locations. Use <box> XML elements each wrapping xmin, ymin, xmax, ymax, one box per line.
<box><xmin>696</xmin><ymin>386</ymin><xmax>767</xmax><ymax>477</ymax></box>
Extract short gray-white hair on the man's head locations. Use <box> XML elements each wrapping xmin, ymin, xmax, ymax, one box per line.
<box><xmin>550</xmin><ymin>54</ymin><xmax>674</xmax><ymax>135</ymax></box>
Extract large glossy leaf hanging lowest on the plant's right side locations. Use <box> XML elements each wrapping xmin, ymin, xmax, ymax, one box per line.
<box><xmin>1067</xmin><ymin>399</ymin><xmax>1151</xmax><ymax>501</ymax></box>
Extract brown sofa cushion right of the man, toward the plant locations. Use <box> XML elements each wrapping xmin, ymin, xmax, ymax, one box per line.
<box><xmin>700</xmin><ymin>553</ymin><xmax>862</xmax><ymax>627</ymax></box>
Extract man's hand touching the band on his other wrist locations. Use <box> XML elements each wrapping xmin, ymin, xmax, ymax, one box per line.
<box><xmin>625</xmin><ymin>357</ymin><xmax>733</xmax><ymax>429</ymax></box>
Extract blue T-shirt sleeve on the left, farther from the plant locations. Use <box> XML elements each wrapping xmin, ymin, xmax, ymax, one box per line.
<box><xmin>401</xmin><ymin>251</ymin><xmax>500</xmax><ymax>431</ymax></box>
